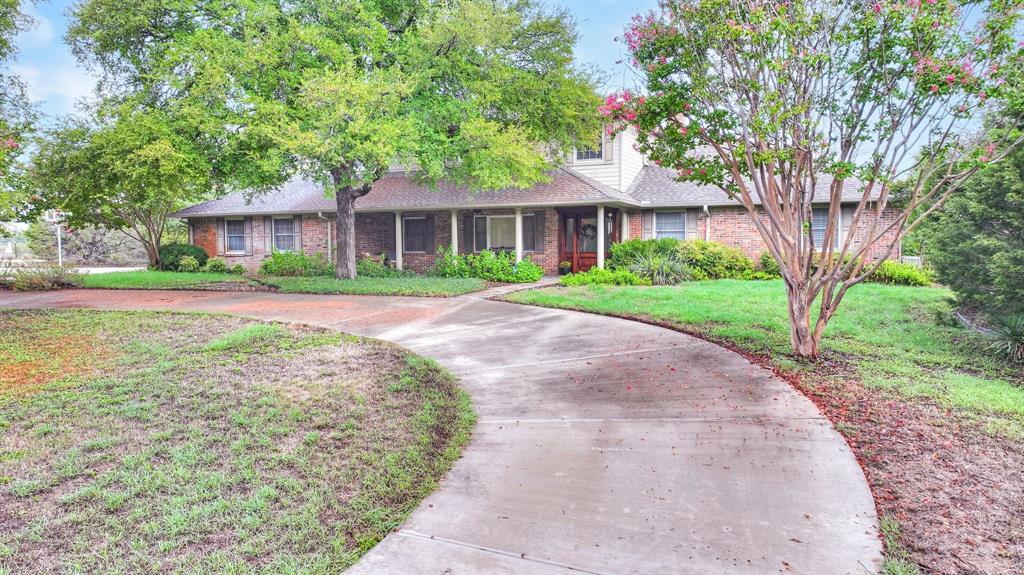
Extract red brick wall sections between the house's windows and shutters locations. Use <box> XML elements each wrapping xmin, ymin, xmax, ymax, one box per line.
<box><xmin>189</xmin><ymin>201</ymin><xmax>900</xmax><ymax>274</ymax></box>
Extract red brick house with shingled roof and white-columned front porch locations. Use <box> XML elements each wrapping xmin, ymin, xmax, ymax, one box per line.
<box><xmin>173</xmin><ymin>131</ymin><xmax>899</xmax><ymax>273</ymax></box>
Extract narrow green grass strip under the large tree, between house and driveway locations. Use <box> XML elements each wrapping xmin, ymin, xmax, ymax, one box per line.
<box><xmin>82</xmin><ymin>271</ymin><xmax>486</xmax><ymax>297</ymax></box>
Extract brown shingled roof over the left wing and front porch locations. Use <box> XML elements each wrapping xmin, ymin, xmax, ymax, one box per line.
<box><xmin>171</xmin><ymin>168</ymin><xmax>637</xmax><ymax>218</ymax></box>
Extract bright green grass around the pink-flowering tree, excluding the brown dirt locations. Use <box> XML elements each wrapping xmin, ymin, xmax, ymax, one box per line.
<box><xmin>509</xmin><ymin>280</ymin><xmax>1024</xmax><ymax>435</ymax></box>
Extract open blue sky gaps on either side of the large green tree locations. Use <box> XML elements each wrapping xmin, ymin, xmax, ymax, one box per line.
<box><xmin>11</xmin><ymin>0</ymin><xmax>656</xmax><ymax>119</ymax></box>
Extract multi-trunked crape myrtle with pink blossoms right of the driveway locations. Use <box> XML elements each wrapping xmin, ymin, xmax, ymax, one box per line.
<box><xmin>601</xmin><ymin>0</ymin><xmax>1021</xmax><ymax>358</ymax></box>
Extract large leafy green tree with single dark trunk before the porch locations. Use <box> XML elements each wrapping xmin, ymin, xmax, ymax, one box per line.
<box><xmin>69</xmin><ymin>0</ymin><xmax>600</xmax><ymax>277</ymax></box>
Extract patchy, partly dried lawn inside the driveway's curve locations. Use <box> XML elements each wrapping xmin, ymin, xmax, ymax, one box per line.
<box><xmin>0</xmin><ymin>311</ymin><xmax>473</xmax><ymax>574</ymax></box>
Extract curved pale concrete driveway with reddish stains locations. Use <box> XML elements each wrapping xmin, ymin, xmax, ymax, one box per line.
<box><xmin>0</xmin><ymin>290</ymin><xmax>881</xmax><ymax>575</ymax></box>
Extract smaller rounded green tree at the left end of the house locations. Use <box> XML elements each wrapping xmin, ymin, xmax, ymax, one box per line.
<box><xmin>26</xmin><ymin>102</ymin><xmax>212</xmax><ymax>267</ymax></box>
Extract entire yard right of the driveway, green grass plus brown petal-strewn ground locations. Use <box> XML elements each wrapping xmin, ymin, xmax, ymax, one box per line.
<box><xmin>507</xmin><ymin>280</ymin><xmax>1024</xmax><ymax>574</ymax></box>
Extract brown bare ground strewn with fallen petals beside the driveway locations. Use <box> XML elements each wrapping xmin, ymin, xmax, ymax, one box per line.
<box><xmin>798</xmin><ymin>380</ymin><xmax>1024</xmax><ymax>575</ymax></box>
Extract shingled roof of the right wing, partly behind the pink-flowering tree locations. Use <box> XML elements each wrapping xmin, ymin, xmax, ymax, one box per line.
<box><xmin>627</xmin><ymin>166</ymin><xmax>879</xmax><ymax>208</ymax></box>
